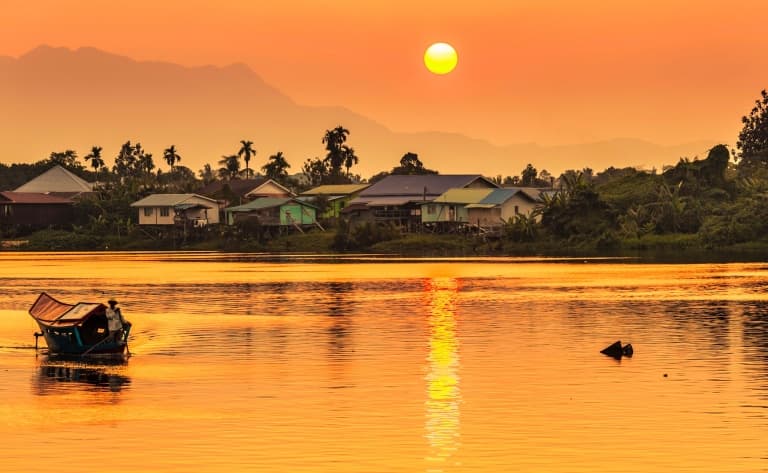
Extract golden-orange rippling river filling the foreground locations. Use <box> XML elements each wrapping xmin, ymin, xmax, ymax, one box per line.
<box><xmin>0</xmin><ymin>252</ymin><xmax>768</xmax><ymax>473</ymax></box>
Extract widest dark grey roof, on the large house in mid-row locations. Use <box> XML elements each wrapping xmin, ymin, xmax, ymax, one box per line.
<box><xmin>357</xmin><ymin>174</ymin><xmax>498</xmax><ymax>201</ymax></box>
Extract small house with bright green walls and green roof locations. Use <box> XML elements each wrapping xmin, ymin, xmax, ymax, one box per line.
<box><xmin>224</xmin><ymin>197</ymin><xmax>317</xmax><ymax>227</ymax></box>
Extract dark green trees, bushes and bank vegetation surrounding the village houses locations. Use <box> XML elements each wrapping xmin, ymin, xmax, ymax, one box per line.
<box><xmin>0</xmin><ymin>91</ymin><xmax>768</xmax><ymax>254</ymax></box>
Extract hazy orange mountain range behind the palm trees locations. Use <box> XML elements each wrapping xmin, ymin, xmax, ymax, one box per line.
<box><xmin>0</xmin><ymin>46</ymin><xmax>718</xmax><ymax>177</ymax></box>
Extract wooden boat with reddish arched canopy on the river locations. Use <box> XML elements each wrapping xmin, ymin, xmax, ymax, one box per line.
<box><xmin>29</xmin><ymin>292</ymin><xmax>131</xmax><ymax>356</ymax></box>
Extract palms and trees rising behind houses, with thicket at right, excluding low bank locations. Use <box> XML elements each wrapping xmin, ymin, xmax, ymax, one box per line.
<box><xmin>0</xmin><ymin>87</ymin><xmax>768</xmax><ymax>248</ymax></box>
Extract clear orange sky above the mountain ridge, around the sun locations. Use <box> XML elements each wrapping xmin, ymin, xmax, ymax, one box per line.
<box><xmin>0</xmin><ymin>0</ymin><xmax>768</xmax><ymax>145</ymax></box>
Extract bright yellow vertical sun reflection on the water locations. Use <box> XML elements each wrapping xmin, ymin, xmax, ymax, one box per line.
<box><xmin>425</xmin><ymin>278</ymin><xmax>461</xmax><ymax>471</ymax></box>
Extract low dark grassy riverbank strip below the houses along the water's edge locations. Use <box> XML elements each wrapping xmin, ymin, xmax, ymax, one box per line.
<box><xmin>0</xmin><ymin>229</ymin><xmax>768</xmax><ymax>262</ymax></box>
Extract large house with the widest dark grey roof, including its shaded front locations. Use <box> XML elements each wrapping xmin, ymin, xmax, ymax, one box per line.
<box><xmin>342</xmin><ymin>174</ymin><xmax>498</xmax><ymax>227</ymax></box>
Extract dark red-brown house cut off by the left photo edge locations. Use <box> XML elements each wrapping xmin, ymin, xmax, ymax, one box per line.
<box><xmin>0</xmin><ymin>191</ymin><xmax>74</xmax><ymax>226</ymax></box>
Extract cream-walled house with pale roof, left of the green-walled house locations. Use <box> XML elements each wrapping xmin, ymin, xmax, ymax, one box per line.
<box><xmin>131</xmin><ymin>194</ymin><xmax>220</xmax><ymax>227</ymax></box>
